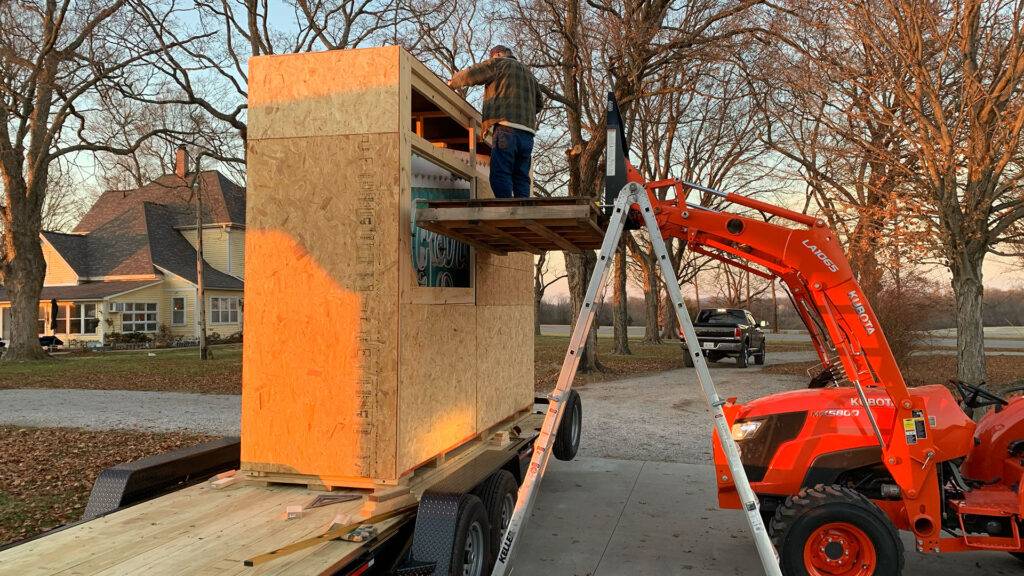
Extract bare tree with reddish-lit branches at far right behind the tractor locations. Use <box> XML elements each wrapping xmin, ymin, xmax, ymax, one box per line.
<box><xmin>770</xmin><ymin>0</ymin><xmax>1024</xmax><ymax>383</ymax></box>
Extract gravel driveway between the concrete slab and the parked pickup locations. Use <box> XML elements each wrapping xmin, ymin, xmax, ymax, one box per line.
<box><xmin>579</xmin><ymin>344</ymin><xmax>817</xmax><ymax>464</ymax></box>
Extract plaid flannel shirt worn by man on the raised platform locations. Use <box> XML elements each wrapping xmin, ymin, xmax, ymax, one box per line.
<box><xmin>449</xmin><ymin>57</ymin><xmax>544</xmax><ymax>134</ymax></box>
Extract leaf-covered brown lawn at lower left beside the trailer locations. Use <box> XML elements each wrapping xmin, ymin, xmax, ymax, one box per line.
<box><xmin>0</xmin><ymin>426</ymin><xmax>210</xmax><ymax>545</ymax></box>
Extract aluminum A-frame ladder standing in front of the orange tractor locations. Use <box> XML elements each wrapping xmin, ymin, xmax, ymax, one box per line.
<box><xmin>492</xmin><ymin>182</ymin><xmax>782</xmax><ymax>576</ymax></box>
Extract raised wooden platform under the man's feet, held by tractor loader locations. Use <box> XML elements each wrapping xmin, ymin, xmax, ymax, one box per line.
<box><xmin>416</xmin><ymin>198</ymin><xmax>606</xmax><ymax>254</ymax></box>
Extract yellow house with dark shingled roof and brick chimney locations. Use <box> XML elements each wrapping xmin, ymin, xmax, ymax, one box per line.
<box><xmin>0</xmin><ymin>151</ymin><xmax>246</xmax><ymax>345</ymax></box>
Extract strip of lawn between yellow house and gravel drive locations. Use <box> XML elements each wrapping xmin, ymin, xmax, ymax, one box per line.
<box><xmin>0</xmin><ymin>344</ymin><xmax>242</xmax><ymax>394</ymax></box>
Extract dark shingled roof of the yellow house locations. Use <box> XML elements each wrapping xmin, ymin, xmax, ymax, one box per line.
<box><xmin>43</xmin><ymin>171</ymin><xmax>246</xmax><ymax>290</ymax></box>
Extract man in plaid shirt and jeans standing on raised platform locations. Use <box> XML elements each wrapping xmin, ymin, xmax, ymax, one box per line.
<box><xmin>449</xmin><ymin>44</ymin><xmax>544</xmax><ymax>198</ymax></box>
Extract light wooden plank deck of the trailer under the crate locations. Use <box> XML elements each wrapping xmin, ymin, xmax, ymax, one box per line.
<box><xmin>0</xmin><ymin>413</ymin><xmax>543</xmax><ymax>576</ymax></box>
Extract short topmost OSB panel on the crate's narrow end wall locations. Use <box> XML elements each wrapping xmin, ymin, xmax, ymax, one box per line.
<box><xmin>249</xmin><ymin>46</ymin><xmax>401</xmax><ymax>140</ymax></box>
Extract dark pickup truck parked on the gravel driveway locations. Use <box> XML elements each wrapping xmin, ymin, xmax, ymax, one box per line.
<box><xmin>683</xmin><ymin>308</ymin><xmax>768</xmax><ymax>368</ymax></box>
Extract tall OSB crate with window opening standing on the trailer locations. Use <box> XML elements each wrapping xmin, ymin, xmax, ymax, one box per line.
<box><xmin>242</xmin><ymin>47</ymin><xmax>534</xmax><ymax>487</ymax></box>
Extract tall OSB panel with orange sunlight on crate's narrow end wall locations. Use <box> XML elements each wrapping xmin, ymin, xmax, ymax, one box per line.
<box><xmin>242</xmin><ymin>134</ymin><xmax>400</xmax><ymax>477</ymax></box>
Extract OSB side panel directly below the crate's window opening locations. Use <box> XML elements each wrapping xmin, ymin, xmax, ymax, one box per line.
<box><xmin>397</xmin><ymin>304</ymin><xmax>479</xmax><ymax>470</ymax></box>
